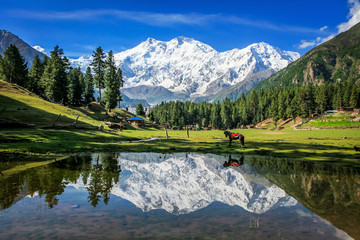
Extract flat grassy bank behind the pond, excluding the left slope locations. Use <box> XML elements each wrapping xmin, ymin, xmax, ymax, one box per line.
<box><xmin>0</xmin><ymin>129</ymin><xmax>360</xmax><ymax>165</ymax></box>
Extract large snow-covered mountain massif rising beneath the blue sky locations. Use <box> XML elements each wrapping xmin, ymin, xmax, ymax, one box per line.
<box><xmin>70</xmin><ymin>37</ymin><xmax>300</xmax><ymax>104</ymax></box>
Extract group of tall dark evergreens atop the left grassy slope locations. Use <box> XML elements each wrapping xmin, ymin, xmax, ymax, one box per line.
<box><xmin>0</xmin><ymin>44</ymin><xmax>123</xmax><ymax>111</ymax></box>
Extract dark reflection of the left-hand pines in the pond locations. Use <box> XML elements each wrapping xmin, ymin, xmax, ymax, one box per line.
<box><xmin>0</xmin><ymin>153</ymin><xmax>121</xmax><ymax>210</ymax></box>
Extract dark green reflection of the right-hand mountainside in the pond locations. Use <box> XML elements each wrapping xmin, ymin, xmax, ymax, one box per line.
<box><xmin>246</xmin><ymin>157</ymin><xmax>360</xmax><ymax>239</ymax></box>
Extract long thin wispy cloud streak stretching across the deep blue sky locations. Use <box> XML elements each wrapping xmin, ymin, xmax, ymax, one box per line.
<box><xmin>8</xmin><ymin>9</ymin><xmax>319</xmax><ymax>33</ymax></box>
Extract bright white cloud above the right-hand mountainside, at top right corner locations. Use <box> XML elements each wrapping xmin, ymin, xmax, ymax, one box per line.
<box><xmin>299</xmin><ymin>0</ymin><xmax>360</xmax><ymax>49</ymax></box>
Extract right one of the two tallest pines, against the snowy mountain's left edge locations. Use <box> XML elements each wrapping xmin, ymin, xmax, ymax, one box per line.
<box><xmin>104</xmin><ymin>51</ymin><xmax>120</xmax><ymax>112</ymax></box>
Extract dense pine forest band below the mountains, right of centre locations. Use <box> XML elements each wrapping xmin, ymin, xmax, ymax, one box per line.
<box><xmin>149</xmin><ymin>80</ymin><xmax>360</xmax><ymax>129</ymax></box>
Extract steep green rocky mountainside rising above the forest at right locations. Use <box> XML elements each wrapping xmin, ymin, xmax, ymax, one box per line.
<box><xmin>255</xmin><ymin>23</ymin><xmax>360</xmax><ymax>89</ymax></box>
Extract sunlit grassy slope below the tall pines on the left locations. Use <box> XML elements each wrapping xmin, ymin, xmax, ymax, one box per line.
<box><xmin>0</xmin><ymin>80</ymin><xmax>134</xmax><ymax>128</ymax></box>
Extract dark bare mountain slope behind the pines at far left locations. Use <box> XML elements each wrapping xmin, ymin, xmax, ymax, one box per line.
<box><xmin>0</xmin><ymin>30</ymin><xmax>44</xmax><ymax>68</ymax></box>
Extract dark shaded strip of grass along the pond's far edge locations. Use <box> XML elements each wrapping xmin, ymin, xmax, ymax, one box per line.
<box><xmin>0</xmin><ymin>125</ymin><xmax>360</xmax><ymax>164</ymax></box>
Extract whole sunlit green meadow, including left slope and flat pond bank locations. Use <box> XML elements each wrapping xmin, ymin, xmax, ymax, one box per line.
<box><xmin>0</xmin><ymin>81</ymin><xmax>360</xmax><ymax>164</ymax></box>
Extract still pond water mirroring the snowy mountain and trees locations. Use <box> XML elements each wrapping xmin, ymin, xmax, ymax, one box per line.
<box><xmin>0</xmin><ymin>153</ymin><xmax>360</xmax><ymax>239</ymax></box>
